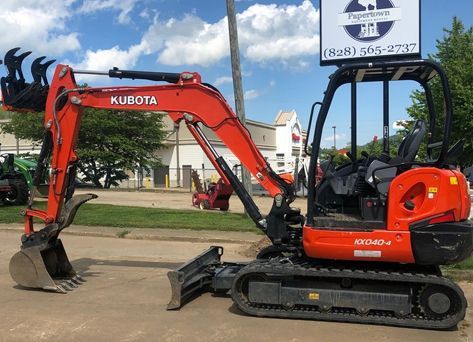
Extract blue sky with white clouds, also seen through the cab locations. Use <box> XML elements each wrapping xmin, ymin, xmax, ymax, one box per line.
<box><xmin>0</xmin><ymin>0</ymin><xmax>473</xmax><ymax>148</ymax></box>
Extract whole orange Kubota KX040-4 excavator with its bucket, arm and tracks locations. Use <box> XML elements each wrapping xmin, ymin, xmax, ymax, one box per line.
<box><xmin>1</xmin><ymin>49</ymin><xmax>473</xmax><ymax>329</ymax></box>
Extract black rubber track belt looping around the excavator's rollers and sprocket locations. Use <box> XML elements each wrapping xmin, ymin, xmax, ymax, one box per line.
<box><xmin>232</xmin><ymin>259</ymin><xmax>467</xmax><ymax>330</ymax></box>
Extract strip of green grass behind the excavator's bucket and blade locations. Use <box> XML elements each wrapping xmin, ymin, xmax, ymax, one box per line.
<box><xmin>0</xmin><ymin>202</ymin><xmax>259</xmax><ymax>235</ymax></box>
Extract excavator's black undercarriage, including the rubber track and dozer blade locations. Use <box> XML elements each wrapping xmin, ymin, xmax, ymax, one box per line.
<box><xmin>168</xmin><ymin>246</ymin><xmax>467</xmax><ymax>329</ymax></box>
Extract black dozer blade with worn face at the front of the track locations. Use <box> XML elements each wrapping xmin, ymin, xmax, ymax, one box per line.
<box><xmin>167</xmin><ymin>246</ymin><xmax>223</xmax><ymax>310</ymax></box>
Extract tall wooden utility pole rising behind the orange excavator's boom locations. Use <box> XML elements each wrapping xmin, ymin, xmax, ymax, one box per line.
<box><xmin>227</xmin><ymin>0</ymin><xmax>253</xmax><ymax>196</ymax></box>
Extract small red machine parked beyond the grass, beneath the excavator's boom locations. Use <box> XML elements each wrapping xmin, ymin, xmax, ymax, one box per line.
<box><xmin>191</xmin><ymin>170</ymin><xmax>233</xmax><ymax>211</ymax></box>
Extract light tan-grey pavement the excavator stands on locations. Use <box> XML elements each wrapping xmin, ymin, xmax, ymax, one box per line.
<box><xmin>0</xmin><ymin>231</ymin><xmax>473</xmax><ymax>342</ymax></box>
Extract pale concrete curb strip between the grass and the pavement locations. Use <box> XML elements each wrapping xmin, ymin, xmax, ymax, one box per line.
<box><xmin>0</xmin><ymin>224</ymin><xmax>263</xmax><ymax>244</ymax></box>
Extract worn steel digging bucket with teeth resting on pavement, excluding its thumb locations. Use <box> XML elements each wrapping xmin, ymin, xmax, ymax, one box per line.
<box><xmin>10</xmin><ymin>228</ymin><xmax>83</xmax><ymax>293</ymax></box>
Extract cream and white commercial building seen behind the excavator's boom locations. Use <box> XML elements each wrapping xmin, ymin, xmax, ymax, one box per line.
<box><xmin>155</xmin><ymin>110</ymin><xmax>305</xmax><ymax>187</ymax></box>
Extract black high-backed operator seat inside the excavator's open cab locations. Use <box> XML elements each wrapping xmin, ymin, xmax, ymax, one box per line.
<box><xmin>365</xmin><ymin>120</ymin><xmax>427</xmax><ymax>195</ymax></box>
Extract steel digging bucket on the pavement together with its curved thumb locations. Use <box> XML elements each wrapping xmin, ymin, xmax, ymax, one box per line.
<box><xmin>9</xmin><ymin>194</ymin><xmax>97</xmax><ymax>293</ymax></box>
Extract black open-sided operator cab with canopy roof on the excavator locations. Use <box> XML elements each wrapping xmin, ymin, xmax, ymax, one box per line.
<box><xmin>306</xmin><ymin>60</ymin><xmax>462</xmax><ymax>229</ymax></box>
